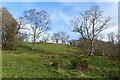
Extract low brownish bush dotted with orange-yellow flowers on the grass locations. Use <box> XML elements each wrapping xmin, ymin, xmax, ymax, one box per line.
<box><xmin>71</xmin><ymin>57</ymin><xmax>89</xmax><ymax>71</ymax></box>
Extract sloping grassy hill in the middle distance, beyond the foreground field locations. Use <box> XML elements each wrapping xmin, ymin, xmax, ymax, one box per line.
<box><xmin>18</xmin><ymin>43</ymin><xmax>80</xmax><ymax>56</ymax></box>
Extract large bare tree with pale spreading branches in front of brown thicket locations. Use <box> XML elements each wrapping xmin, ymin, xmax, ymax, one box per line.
<box><xmin>71</xmin><ymin>5</ymin><xmax>111</xmax><ymax>56</ymax></box>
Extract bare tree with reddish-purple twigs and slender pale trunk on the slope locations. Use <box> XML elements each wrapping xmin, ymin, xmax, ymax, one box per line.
<box><xmin>24</xmin><ymin>9</ymin><xmax>51</xmax><ymax>50</ymax></box>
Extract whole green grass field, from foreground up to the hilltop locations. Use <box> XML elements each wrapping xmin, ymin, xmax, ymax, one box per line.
<box><xmin>2</xmin><ymin>42</ymin><xmax>120</xmax><ymax>78</ymax></box>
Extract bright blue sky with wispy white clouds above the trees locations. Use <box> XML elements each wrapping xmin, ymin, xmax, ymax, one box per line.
<box><xmin>2</xmin><ymin>0</ymin><xmax>118</xmax><ymax>41</ymax></box>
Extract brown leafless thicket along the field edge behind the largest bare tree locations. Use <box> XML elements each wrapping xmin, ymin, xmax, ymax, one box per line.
<box><xmin>69</xmin><ymin>32</ymin><xmax>120</xmax><ymax>57</ymax></box>
